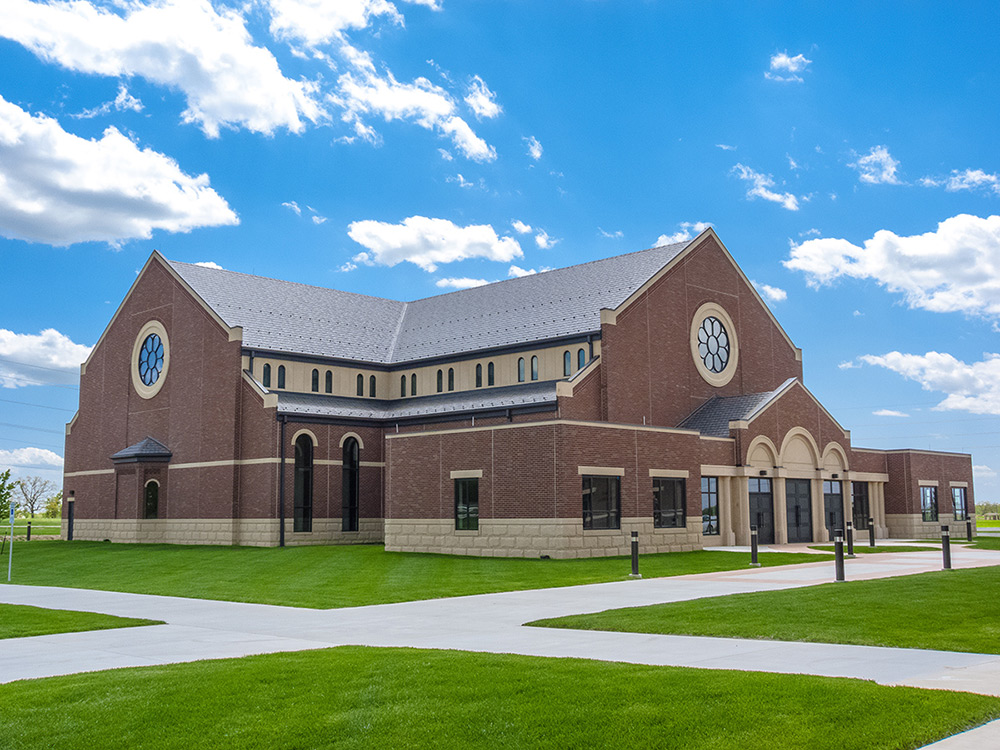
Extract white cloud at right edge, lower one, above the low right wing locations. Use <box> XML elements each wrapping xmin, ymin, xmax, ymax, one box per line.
<box><xmin>860</xmin><ymin>352</ymin><xmax>1000</xmax><ymax>415</ymax></box>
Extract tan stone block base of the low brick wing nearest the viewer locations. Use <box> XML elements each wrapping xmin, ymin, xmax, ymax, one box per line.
<box><xmin>385</xmin><ymin>517</ymin><xmax>702</xmax><ymax>559</ymax></box>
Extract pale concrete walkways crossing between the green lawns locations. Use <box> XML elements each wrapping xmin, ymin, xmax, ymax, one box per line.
<box><xmin>0</xmin><ymin>545</ymin><xmax>1000</xmax><ymax>750</ymax></box>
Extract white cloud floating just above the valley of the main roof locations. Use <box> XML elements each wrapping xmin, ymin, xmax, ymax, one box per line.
<box><xmin>347</xmin><ymin>216</ymin><xmax>523</xmax><ymax>272</ymax></box>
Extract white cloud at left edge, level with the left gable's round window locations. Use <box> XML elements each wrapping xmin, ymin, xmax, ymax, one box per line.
<box><xmin>0</xmin><ymin>328</ymin><xmax>93</xmax><ymax>388</ymax></box>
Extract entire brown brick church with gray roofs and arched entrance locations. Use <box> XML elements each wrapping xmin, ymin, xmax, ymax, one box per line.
<box><xmin>64</xmin><ymin>229</ymin><xmax>973</xmax><ymax>557</ymax></box>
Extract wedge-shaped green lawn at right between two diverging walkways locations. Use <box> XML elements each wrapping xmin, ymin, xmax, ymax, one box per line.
<box><xmin>531</xmin><ymin>567</ymin><xmax>1000</xmax><ymax>654</ymax></box>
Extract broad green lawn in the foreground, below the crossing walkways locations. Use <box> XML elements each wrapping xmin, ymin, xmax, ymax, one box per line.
<box><xmin>0</xmin><ymin>647</ymin><xmax>1000</xmax><ymax>750</ymax></box>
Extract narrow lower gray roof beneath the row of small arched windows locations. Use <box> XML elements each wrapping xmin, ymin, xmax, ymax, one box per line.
<box><xmin>272</xmin><ymin>380</ymin><xmax>559</xmax><ymax>421</ymax></box>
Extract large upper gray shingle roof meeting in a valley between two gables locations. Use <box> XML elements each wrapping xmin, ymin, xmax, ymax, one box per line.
<box><xmin>167</xmin><ymin>242</ymin><xmax>688</xmax><ymax>364</ymax></box>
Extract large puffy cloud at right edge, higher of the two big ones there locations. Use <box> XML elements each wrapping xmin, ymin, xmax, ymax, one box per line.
<box><xmin>783</xmin><ymin>214</ymin><xmax>1000</xmax><ymax>317</ymax></box>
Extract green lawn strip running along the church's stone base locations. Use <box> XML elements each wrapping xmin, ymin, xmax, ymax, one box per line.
<box><xmin>1</xmin><ymin>541</ymin><xmax>833</xmax><ymax>608</ymax></box>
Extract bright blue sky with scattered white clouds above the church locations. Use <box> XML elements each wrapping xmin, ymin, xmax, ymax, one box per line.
<box><xmin>0</xmin><ymin>0</ymin><xmax>1000</xmax><ymax>501</ymax></box>
